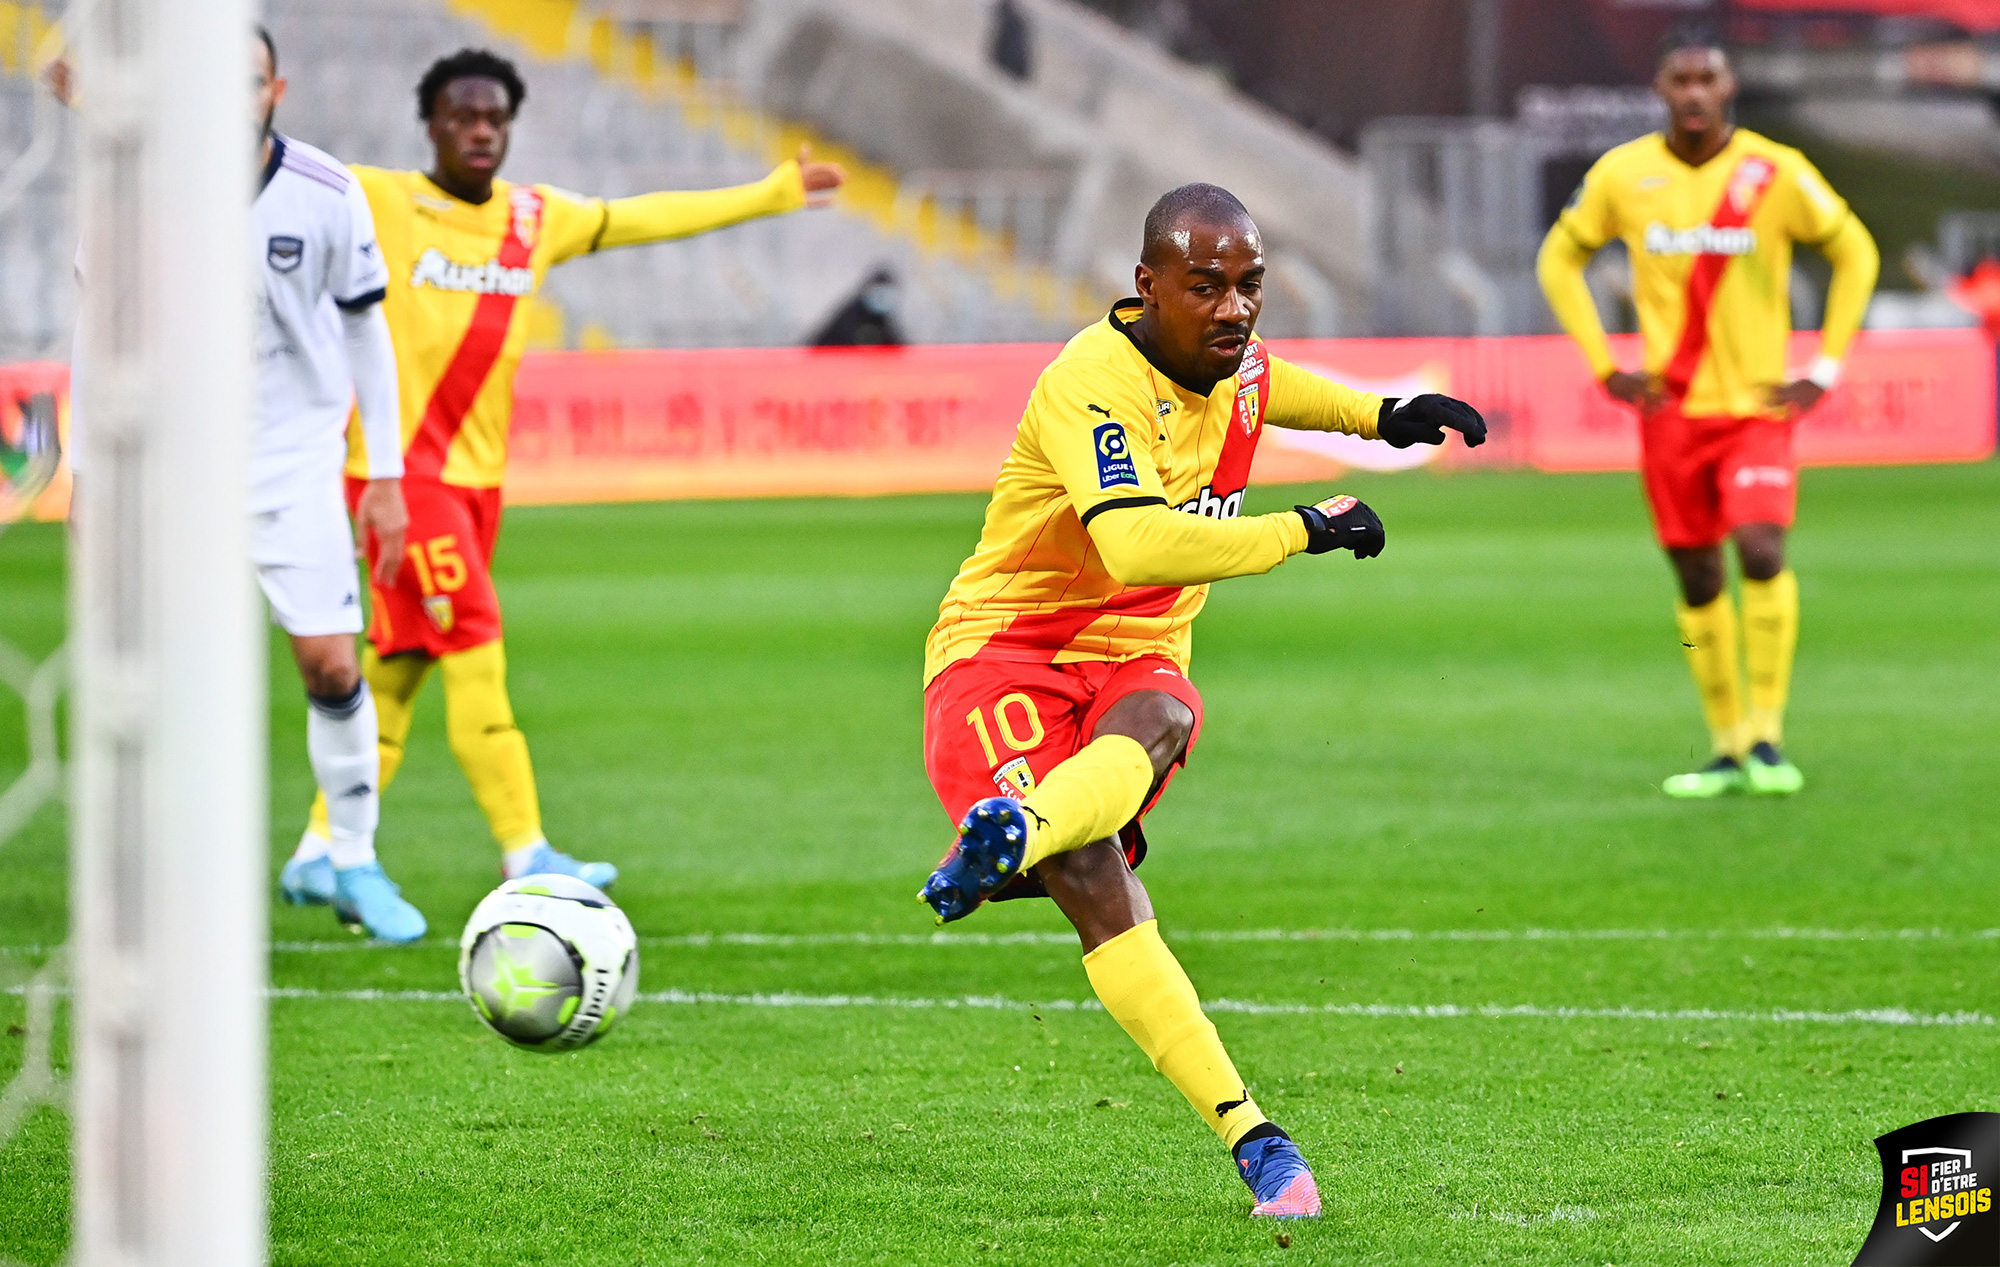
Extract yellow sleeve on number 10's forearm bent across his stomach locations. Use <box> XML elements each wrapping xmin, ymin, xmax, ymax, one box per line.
<box><xmin>1086</xmin><ymin>497</ymin><xmax>1306</xmax><ymax>586</ymax></box>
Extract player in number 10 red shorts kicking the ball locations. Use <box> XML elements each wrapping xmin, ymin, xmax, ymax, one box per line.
<box><xmin>918</xmin><ymin>184</ymin><xmax>1486</xmax><ymax>1217</ymax></box>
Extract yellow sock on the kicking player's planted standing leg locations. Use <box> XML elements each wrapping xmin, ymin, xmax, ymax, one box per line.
<box><xmin>1084</xmin><ymin>919</ymin><xmax>1270</xmax><ymax>1147</ymax></box>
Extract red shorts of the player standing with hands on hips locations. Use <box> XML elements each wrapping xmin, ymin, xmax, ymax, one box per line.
<box><xmin>1640</xmin><ymin>406</ymin><xmax>1798</xmax><ymax>550</ymax></box>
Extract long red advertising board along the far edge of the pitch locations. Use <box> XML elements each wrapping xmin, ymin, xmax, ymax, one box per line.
<box><xmin>0</xmin><ymin>330</ymin><xmax>1994</xmax><ymax>518</ymax></box>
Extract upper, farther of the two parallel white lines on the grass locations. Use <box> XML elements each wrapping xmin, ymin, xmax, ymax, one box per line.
<box><xmin>0</xmin><ymin>927</ymin><xmax>2000</xmax><ymax>955</ymax></box>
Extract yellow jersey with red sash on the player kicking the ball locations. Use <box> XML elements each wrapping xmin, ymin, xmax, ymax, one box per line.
<box><xmin>924</xmin><ymin>300</ymin><xmax>1382</xmax><ymax>683</ymax></box>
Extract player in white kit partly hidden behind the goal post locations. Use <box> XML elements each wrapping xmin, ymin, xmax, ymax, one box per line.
<box><xmin>239</xmin><ymin>28</ymin><xmax>426</xmax><ymax>941</ymax></box>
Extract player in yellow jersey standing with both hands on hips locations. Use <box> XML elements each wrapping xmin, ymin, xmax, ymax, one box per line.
<box><xmin>1538</xmin><ymin>30</ymin><xmax>1880</xmax><ymax>797</ymax></box>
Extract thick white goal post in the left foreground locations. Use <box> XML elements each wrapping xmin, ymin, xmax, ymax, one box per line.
<box><xmin>70</xmin><ymin>0</ymin><xmax>268</xmax><ymax>1267</ymax></box>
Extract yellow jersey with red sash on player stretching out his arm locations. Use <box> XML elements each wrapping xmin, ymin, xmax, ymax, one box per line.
<box><xmin>348</xmin><ymin>162</ymin><xmax>806</xmax><ymax>488</ymax></box>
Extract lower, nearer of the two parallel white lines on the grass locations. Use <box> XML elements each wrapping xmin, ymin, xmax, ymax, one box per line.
<box><xmin>242</xmin><ymin>987</ymin><xmax>1994</xmax><ymax>1025</ymax></box>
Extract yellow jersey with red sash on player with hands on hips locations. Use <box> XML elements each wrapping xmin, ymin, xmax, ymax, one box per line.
<box><xmin>1552</xmin><ymin>128</ymin><xmax>1854</xmax><ymax>418</ymax></box>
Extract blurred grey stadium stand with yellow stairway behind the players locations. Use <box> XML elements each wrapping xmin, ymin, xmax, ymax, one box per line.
<box><xmin>0</xmin><ymin>0</ymin><xmax>1370</xmax><ymax>360</ymax></box>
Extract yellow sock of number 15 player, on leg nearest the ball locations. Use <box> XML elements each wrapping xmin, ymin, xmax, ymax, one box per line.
<box><xmin>438</xmin><ymin>641</ymin><xmax>542</xmax><ymax>849</ymax></box>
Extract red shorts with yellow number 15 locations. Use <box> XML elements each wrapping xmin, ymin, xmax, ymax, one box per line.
<box><xmin>348</xmin><ymin>476</ymin><xmax>500</xmax><ymax>657</ymax></box>
